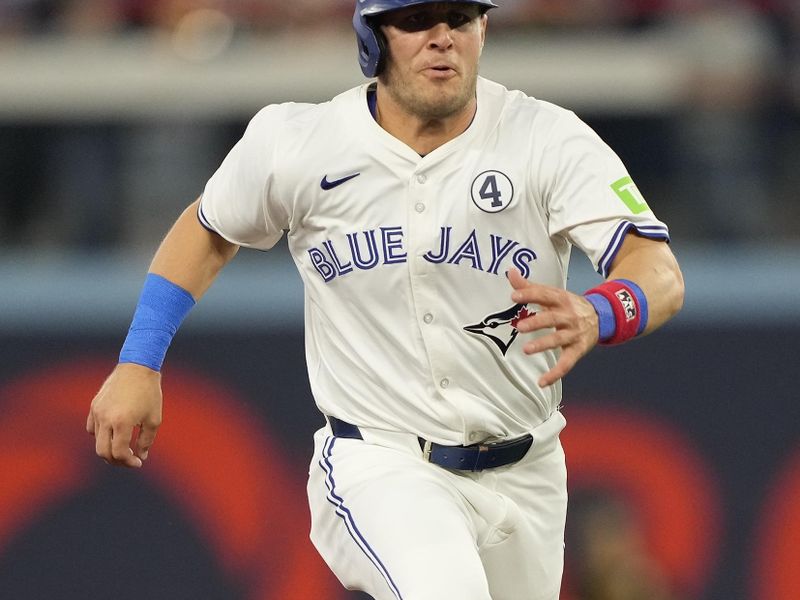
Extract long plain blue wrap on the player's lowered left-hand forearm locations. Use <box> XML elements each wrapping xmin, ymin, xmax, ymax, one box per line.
<box><xmin>119</xmin><ymin>273</ymin><xmax>195</xmax><ymax>371</ymax></box>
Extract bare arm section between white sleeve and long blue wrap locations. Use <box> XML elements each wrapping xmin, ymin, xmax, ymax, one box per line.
<box><xmin>150</xmin><ymin>200</ymin><xmax>239</xmax><ymax>300</ymax></box>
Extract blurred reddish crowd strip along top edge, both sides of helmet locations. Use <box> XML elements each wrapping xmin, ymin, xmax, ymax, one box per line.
<box><xmin>0</xmin><ymin>0</ymin><xmax>800</xmax><ymax>35</ymax></box>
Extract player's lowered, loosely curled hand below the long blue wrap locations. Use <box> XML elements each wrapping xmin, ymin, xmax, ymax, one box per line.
<box><xmin>86</xmin><ymin>363</ymin><xmax>162</xmax><ymax>468</ymax></box>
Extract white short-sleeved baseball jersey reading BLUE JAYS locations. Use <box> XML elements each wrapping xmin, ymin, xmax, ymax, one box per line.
<box><xmin>200</xmin><ymin>78</ymin><xmax>668</xmax><ymax>444</ymax></box>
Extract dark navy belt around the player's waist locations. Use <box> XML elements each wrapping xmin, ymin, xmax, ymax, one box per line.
<box><xmin>328</xmin><ymin>417</ymin><xmax>533</xmax><ymax>471</ymax></box>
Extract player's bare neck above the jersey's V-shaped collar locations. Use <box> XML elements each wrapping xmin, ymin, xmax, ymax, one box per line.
<box><xmin>375</xmin><ymin>87</ymin><xmax>478</xmax><ymax>156</ymax></box>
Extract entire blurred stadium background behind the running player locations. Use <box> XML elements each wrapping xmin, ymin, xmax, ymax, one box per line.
<box><xmin>0</xmin><ymin>0</ymin><xmax>800</xmax><ymax>600</ymax></box>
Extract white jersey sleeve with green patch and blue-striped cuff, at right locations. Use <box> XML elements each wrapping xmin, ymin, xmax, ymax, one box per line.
<box><xmin>540</xmin><ymin>112</ymin><xmax>669</xmax><ymax>277</ymax></box>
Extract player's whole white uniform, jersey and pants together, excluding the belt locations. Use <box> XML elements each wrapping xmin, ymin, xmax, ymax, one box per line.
<box><xmin>199</xmin><ymin>78</ymin><xmax>668</xmax><ymax>600</ymax></box>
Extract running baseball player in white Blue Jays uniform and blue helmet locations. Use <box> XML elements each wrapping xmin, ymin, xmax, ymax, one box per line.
<box><xmin>87</xmin><ymin>0</ymin><xmax>683</xmax><ymax>600</ymax></box>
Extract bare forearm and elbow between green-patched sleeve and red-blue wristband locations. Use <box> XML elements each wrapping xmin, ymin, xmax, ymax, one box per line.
<box><xmin>608</xmin><ymin>236</ymin><xmax>684</xmax><ymax>335</ymax></box>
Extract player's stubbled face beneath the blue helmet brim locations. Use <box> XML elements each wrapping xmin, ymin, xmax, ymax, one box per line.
<box><xmin>380</xmin><ymin>2</ymin><xmax>487</xmax><ymax>120</ymax></box>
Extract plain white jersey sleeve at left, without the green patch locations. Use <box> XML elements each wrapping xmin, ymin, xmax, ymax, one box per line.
<box><xmin>198</xmin><ymin>106</ymin><xmax>289</xmax><ymax>250</ymax></box>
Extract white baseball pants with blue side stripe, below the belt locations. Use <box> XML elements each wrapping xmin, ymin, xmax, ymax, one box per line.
<box><xmin>308</xmin><ymin>412</ymin><xmax>567</xmax><ymax>600</ymax></box>
